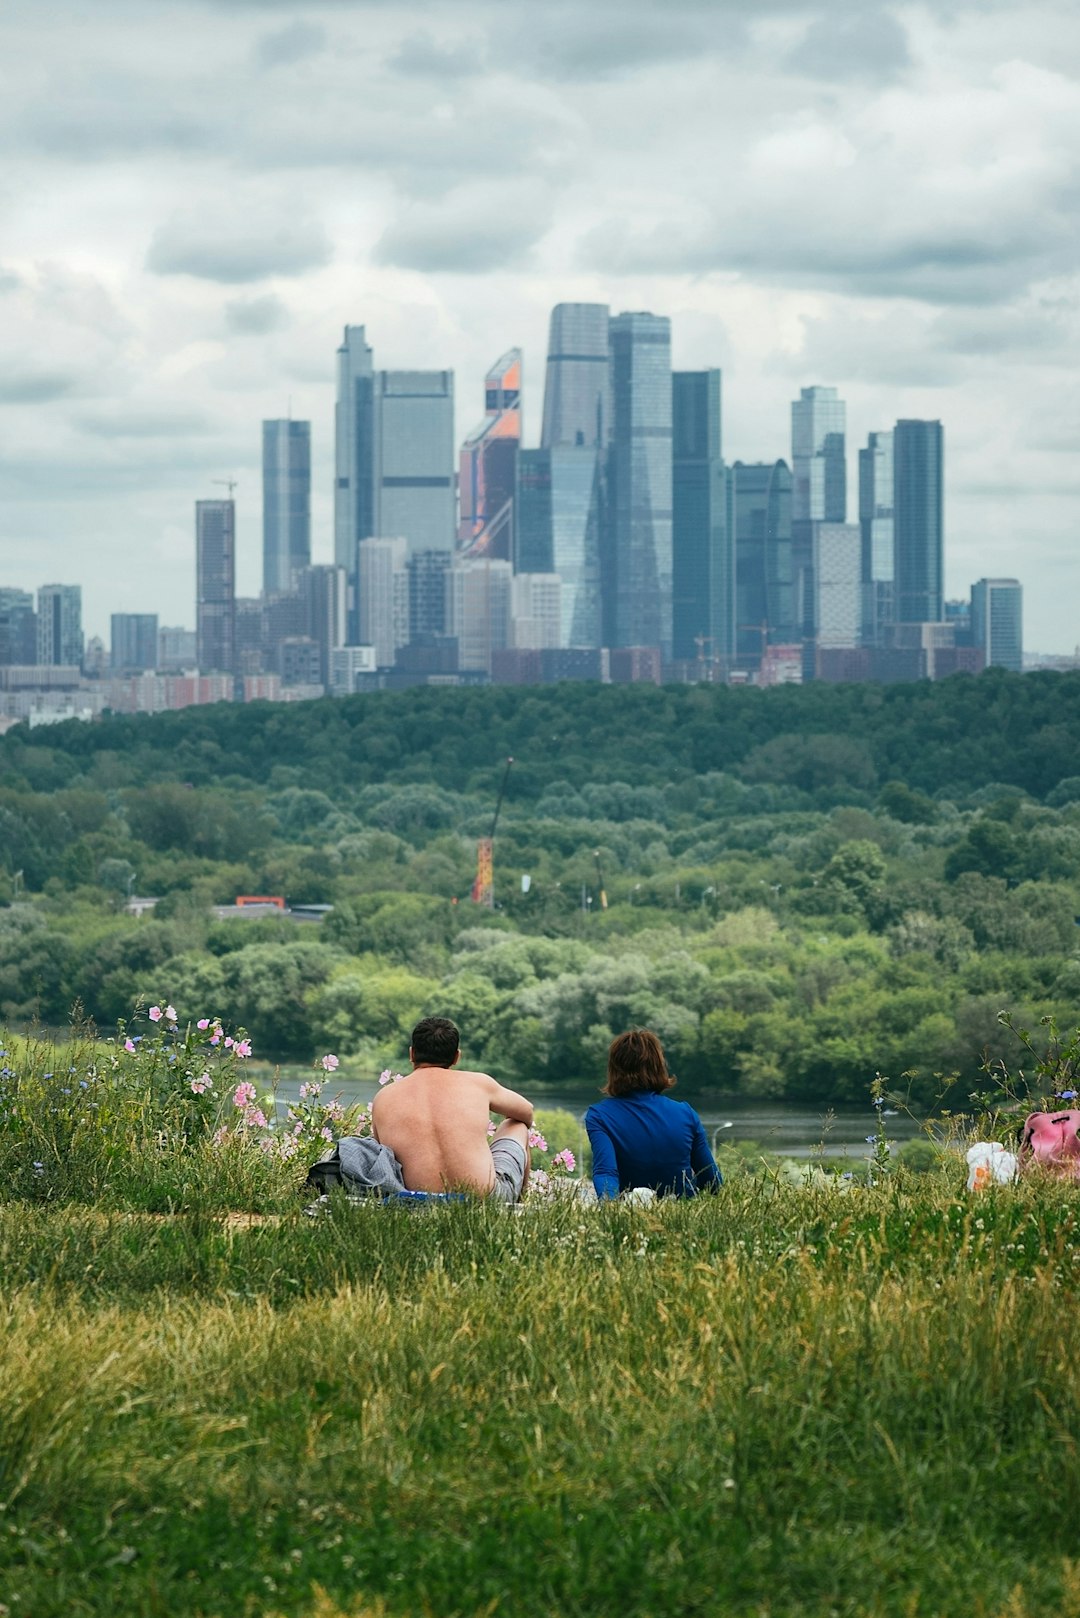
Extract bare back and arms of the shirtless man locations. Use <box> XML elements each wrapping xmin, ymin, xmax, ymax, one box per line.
<box><xmin>371</xmin><ymin>1052</ymin><xmax>533</xmax><ymax>1196</ymax></box>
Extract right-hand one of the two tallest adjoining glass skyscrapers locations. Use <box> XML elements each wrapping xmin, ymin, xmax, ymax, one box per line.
<box><xmin>601</xmin><ymin>314</ymin><xmax>672</xmax><ymax>660</ymax></box>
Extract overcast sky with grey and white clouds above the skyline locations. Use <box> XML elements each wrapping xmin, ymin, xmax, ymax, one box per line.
<box><xmin>0</xmin><ymin>0</ymin><xmax>1080</xmax><ymax>652</ymax></box>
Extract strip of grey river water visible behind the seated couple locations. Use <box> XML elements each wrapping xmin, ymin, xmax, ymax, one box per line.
<box><xmin>279</xmin><ymin>1074</ymin><xmax>921</xmax><ymax>1160</ymax></box>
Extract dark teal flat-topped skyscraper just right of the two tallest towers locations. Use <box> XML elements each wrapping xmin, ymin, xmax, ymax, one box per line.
<box><xmin>672</xmin><ymin>371</ymin><xmax>735</xmax><ymax>668</ymax></box>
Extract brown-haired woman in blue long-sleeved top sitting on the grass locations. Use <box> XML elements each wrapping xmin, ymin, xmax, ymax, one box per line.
<box><xmin>585</xmin><ymin>1027</ymin><xmax>722</xmax><ymax>1202</ymax></box>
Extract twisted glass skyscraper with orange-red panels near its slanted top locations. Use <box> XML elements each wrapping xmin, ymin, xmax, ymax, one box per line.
<box><xmin>458</xmin><ymin>348</ymin><xmax>521</xmax><ymax>561</ymax></box>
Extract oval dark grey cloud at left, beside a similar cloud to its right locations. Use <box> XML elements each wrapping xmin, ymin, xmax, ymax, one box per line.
<box><xmin>146</xmin><ymin>211</ymin><xmax>332</xmax><ymax>285</ymax></box>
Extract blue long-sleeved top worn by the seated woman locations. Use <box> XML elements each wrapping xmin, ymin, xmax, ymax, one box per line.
<box><xmin>585</xmin><ymin>1091</ymin><xmax>724</xmax><ymax>1201</ymax></box>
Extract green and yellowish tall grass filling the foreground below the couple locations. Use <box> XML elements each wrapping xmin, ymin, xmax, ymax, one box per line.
<box><xmin>0</xmin><ymin>1176</ymin><xmax>1080</xmax><ymax>1618</ymax></box>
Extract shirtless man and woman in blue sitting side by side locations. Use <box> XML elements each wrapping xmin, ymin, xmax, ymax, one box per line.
<box><xmin>362</xmin><ymin>1016</ymin><xmax>721</xmax><ymax>1202</ymax></box>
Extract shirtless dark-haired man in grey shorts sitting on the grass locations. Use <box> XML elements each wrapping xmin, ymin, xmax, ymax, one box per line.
<box><xmin>371</xmin><ymin>1016</ymin><xmax>533</xmax><ymax>1202</ymax></box>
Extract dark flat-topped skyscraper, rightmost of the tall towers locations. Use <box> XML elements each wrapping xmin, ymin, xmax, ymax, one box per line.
<box><xmin>892</xmin><ymin>421</ymin><xmax>944</xmax><ymax>623</ymax></box>
